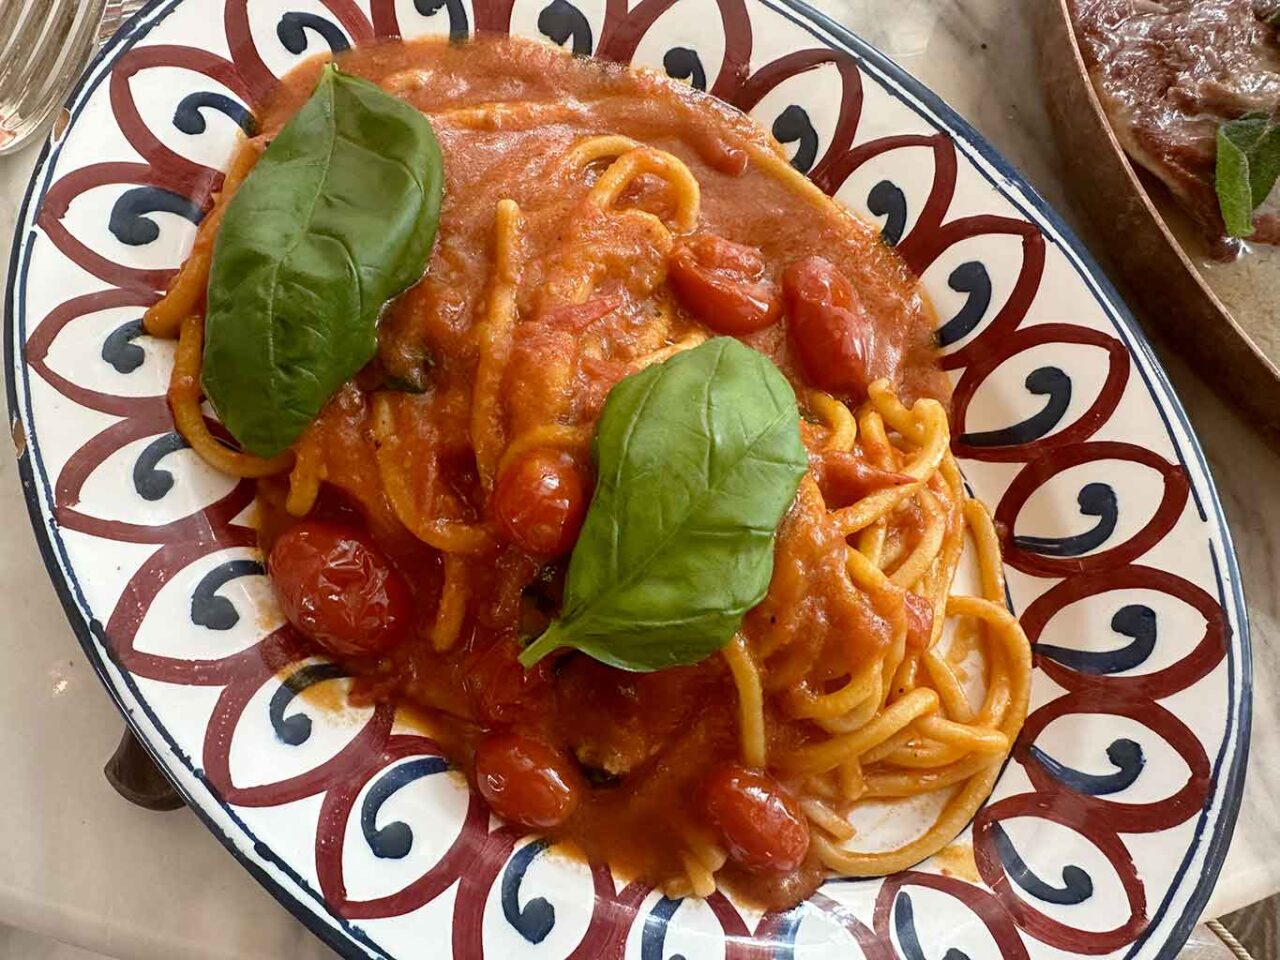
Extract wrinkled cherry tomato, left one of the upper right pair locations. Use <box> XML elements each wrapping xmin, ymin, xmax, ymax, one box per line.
<box><xmin>667</xmin><ymin>233</ymin><xmax>782</xmax><ymax>337</ymax></box>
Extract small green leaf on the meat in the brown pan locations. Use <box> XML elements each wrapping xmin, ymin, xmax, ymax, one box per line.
<box><xmin>1215</xmin><ymin>113</ymin><xmax>1280</xmax><ymax>237</ymax></box>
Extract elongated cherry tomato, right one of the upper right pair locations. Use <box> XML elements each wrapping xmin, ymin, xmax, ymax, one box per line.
<box><xmin>782</xmin><ymin>257</ymin><xmax>872</xmax><ymax>396</ymax></box>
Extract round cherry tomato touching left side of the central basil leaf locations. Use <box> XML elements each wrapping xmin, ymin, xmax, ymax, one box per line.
<box><xmin>493</xmin><ymin>448</ymin><xmax>590</xmax><ymax>557</ymax></box>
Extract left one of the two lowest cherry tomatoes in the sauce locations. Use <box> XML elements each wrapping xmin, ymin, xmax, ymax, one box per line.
<box><xmin>476</xmin><ymin>733</ymin><xmax>584</xmax><ymax>829</ymax></box>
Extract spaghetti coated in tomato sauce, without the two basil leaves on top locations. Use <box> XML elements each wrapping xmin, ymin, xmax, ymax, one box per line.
<box><xmin>146</xmin><ymin>35</ymin><xmax>1030</xmax><ymax>906</ymax></box>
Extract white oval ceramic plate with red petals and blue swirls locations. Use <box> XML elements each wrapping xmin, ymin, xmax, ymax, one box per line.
<box><xmin>6</xmin><ymin>0</ymin><xmax>1249</xmax><ymax>960</ymax></box>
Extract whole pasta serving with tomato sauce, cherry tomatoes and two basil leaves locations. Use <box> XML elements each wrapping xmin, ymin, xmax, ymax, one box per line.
<box><xmin>146</xmin><ymin>38</ymin><xmax>1030</xmax><ymax>908</ymax></box>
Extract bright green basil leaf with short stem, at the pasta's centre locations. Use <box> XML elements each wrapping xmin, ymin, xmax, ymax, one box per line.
<box><xmin>520</xmin><ymin>338</ymin><xmax>808</xmax><ymax>671</ymax></box>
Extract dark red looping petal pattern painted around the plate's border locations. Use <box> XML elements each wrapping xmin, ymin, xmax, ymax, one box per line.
<box><xmin>7</xmin><ymin>0</ymin><xmax>1231</xmax><ymax>960</ymax></box>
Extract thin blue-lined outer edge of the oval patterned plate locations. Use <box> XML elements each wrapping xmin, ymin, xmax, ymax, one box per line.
<box><xmin>4</xmin><ymin>0</ymin><xmax>1253</xmax><ymax>960</ymax></box>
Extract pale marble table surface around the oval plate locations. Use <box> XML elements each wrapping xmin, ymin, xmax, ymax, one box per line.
<box><xmin>0</xmin><ymin>0</ymin><xmax>1280</xmax><ymax>960</ymax></box>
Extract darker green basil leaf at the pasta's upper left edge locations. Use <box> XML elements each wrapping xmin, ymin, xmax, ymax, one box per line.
<box><xmin>204</xmin><ymin>65</ymin><xmax>444</xmax><ymax>457</ymax></box>
